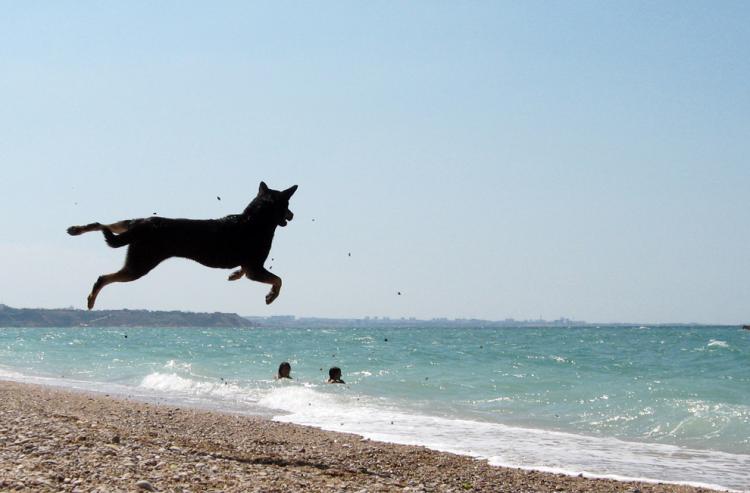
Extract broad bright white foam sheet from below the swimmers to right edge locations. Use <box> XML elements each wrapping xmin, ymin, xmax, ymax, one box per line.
<box><xmin>259</xmin><ymin>386</ymin><xmax>750</xmax><ymax>490</ymax></box>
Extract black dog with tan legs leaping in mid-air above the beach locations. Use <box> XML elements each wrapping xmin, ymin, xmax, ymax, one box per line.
<box><xmin>68</xmin><ymin>182</ymin><xmax>297</xmax><ymax>310</ymax></box>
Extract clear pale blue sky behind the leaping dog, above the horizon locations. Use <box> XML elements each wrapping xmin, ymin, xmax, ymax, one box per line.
<box><xmin>0</xmin><ymin>1</ymin><xmax>750</xmax><ymax>323</ymax></box>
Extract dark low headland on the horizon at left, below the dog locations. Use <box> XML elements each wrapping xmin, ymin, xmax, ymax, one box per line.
<box><xmin>0</xmin><ymin>304</ymin><xmax>256</xmax><ymax>327</ymax></box>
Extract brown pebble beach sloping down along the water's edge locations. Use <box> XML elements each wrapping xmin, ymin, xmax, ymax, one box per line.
<box><xmin>0</xmin><ymin>381</ymin><xmax>728</xmax><ymax>493</ymax></box>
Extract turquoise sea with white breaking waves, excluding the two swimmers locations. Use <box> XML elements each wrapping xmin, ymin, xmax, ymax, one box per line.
<box><xmin>0</xmin><ymin>326</ymin><xmax>750</xmax><ymax>490</ymax></box>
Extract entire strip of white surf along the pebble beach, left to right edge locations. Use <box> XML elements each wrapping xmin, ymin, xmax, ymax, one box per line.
<box><xmin>0</xmin><ymin>368</ymin><xmax>750</xmax><ymax>490</ymax></box>
